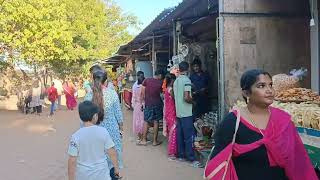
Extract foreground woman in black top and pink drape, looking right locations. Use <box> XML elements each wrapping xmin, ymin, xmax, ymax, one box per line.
<box><xmin>205</xmin><ymin>69</ymin><xmax>318</xmax><ymax>180</ymax></box>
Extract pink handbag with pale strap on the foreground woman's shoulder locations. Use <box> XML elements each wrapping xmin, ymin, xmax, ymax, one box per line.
<box><xmin>204</xmin><ymin>109</ymin><xmax>240</xmax><ymax>180</ymax></box>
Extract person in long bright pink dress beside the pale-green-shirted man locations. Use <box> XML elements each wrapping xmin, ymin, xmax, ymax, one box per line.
<box><xmin>164</xmin><ymin>74</ymin><xmax>177</xmax><ymax>160</ymax></box>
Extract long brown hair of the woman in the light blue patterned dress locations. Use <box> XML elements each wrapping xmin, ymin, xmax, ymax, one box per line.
<box><xmin>92</xmin><ymin>70</ymin><xmax>108</xmax><ymax>124</ymax></box>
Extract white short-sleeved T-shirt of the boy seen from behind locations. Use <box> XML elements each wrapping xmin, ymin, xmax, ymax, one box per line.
<box><xmin>68</xmin><ymin>126</ymin><xmax>114</xmax><ymax>180</ymax></box>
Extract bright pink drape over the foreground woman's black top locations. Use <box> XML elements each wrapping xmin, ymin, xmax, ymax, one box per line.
<box><xmin>205</xmin><ymin>107</ymin><xmax>318</xmax><ymax>180</ymax></box>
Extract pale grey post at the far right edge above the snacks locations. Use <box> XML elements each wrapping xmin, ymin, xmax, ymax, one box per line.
<box><xmin>310</xmin><ymin>0</ymin><xmax>320</xmax><ymax>92</ymax></box>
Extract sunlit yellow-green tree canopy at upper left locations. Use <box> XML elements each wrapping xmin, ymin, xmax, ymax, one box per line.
<box><xmin>0</xmin><ymin>0</ymin><xmax>139</xmax><ymax>73</ymax></box>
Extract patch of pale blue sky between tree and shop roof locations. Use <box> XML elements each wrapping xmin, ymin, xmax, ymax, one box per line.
<box><xmin>115</xmin><ymin>0</ymin><xmax>182</xmax><ymax>33</ymax></box>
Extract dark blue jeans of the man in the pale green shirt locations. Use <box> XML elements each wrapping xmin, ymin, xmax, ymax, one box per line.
<box><xmin>177</xmin><ymin>116</ymin><xmax>196</xmax><ymax>161</ymax></box>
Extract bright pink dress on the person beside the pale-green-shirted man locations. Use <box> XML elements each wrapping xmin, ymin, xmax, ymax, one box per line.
<box><xmin>164</xmin><ymin>88</ymin><xmax>177</xmax><ymax>156</ymax></box>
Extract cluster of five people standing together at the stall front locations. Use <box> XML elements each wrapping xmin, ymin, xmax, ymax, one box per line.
<box><xmin>132</xmin><ymin>58</ymin><xmax>209</xmax><ymax>167</ymax></box>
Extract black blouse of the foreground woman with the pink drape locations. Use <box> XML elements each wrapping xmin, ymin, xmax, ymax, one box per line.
<box><xmin>210</xmin><ymin>113</ymin><xmax>288</xmax><ymax>180</ymax></box>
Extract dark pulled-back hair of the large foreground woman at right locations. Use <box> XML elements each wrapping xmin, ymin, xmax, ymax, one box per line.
<box><xmin>240</xmin><ymin>69</ymin><xmax>272</xmax><ymax>103</ymax></box>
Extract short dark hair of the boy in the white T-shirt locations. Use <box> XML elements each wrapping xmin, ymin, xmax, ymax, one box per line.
<box><xmin>78</xmin><ymin>101</ymin><xmax>99</xmax><ymax>122</ymax></box>
